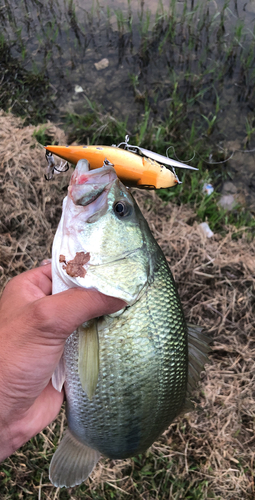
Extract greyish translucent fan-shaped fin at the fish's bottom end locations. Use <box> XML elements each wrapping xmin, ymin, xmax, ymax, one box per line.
<box><xmin>49</xmin><ymin>429</ymin><xmax>100</xmax><ymax>488</ymax></box>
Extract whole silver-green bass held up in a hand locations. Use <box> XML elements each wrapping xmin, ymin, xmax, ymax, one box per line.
<box><xmin>49</xmin><ymin>159</ymin><xmax>209</xmax><ymax>487</ymax></box>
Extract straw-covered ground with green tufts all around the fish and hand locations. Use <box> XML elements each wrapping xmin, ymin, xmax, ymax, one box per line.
<box><xmin>0</xmin><ymin>109</ymin><xmax>255</xmax><ymax>500</ymax></box>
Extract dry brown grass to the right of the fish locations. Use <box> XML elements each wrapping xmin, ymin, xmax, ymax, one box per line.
<box><xmin>136</xmin><ymin>190</ymin><xmax>255</xmax><ymax>500</ymax></box>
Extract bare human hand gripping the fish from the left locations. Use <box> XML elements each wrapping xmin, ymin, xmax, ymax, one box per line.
<box><xmin>0</xmin><ymin>264</ymin><xmax>124</xmax><ymax>461</ymax></box>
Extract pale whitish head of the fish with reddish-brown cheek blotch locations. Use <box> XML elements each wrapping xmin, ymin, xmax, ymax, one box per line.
<box><xmin>54</xmin><ymin>160</ymin><xmax>150</xmax><ymax>305</ymax></box>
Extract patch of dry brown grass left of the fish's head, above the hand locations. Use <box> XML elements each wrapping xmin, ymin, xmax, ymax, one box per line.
<box><xmin>0</xmin><ymin>112</ymin><xmax>68</xmax><ymax>290</ymax></box>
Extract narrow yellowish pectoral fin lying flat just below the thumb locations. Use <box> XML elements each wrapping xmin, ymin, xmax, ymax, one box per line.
<box><xmin>78</xmin><ymin>320</ymin><xmax>99</xmax><ymax>399</ymax></box>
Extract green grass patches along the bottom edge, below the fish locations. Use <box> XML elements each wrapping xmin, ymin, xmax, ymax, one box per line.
<box><xmin>0</xmin><ymin>442</ymin><xmax>211</xmax><ymax>500</ymax></box>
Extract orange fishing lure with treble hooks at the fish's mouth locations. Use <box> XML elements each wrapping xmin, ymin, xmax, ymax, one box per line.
<box><xmin>45</xmin><ymin>136</ymin><xmax>198</xmax><ymax>189</ymax></box>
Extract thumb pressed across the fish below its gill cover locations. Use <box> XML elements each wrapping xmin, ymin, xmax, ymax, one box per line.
<box><xmin>28</xmin><ymin>288</ymin><xmax>126</xmax><ymax>339</ymax></box>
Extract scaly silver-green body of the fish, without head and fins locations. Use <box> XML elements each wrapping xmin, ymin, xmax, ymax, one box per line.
<box><xmin>65</xmin><ymin>249</ymin><xmax>187</xmax><ymax>458</ymax></box>
